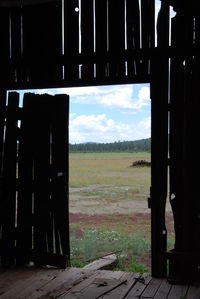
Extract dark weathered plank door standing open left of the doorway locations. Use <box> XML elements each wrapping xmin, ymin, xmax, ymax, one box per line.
<box><xmin>0</xmin><ymin>93</ymin><xmax>70</xmax><ymax>268</ymax></box>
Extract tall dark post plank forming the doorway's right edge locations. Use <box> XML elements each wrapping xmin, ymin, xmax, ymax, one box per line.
<box><xmin>151</xmin><ymin>3</ymin><xmax>169</xmax><ymax>277</ymax></box>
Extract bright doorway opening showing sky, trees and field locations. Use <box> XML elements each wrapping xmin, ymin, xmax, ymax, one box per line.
<box><xmin>9</xmin><ymin>84</ymin><xmax>173</xmax><ymax>272</ymax></box>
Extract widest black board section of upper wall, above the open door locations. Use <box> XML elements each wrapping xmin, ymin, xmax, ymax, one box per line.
<box><xmin>23</xmin><ymin>2</ymin><xmax>62</xmax><ymax>82</ymax></box>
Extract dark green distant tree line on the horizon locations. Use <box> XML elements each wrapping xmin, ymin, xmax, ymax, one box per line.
<box><xmin>69</xmin><ymin>138</ymin><xmax>151</xmax><ymax>153</ymax></box>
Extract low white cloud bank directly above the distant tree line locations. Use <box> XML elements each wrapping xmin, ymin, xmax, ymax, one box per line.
<box><xmin>69</xmin><ymin>114</ymin><xmax>150</xmax><ymax>143</ymax></box>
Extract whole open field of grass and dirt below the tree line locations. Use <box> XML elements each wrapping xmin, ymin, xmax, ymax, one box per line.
<box><xmin>69</xmin><ymin>153</ymin><xmax>173</xmax><ymax>272</ymax></box>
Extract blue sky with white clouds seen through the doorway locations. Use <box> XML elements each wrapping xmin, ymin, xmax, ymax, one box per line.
<box><xmin>15</xmin><ymin>0</ymin><xmax>175</xmax><ymax>143</ymax></box>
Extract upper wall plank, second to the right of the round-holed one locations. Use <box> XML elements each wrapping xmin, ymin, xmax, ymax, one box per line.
<box><xmin>95</xmin><ymin>0</ymin><xmax>108</xmax><ymax>80</ymax></box>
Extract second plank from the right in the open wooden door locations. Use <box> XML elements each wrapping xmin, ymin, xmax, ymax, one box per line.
<box><xmin>32</xmin><ymin>95</ymin><xmax>53</xmax><ymax>252</ymax></box>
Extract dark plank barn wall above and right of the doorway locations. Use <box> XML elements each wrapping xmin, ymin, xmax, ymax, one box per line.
<box><xmin>0</xmin><ymin>0</ymin><xmax>200</xmax><ymax>280</ymax></box>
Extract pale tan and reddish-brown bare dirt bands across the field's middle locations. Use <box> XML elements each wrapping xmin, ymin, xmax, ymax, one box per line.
<box><xmin>69</xmin><ymin>186</ymin><xmax>173</xmax><ymax>237</ymax></box>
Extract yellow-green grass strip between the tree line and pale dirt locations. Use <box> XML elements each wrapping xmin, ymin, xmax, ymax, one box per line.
<box><xmin>69</xmin><ymin>153</ymin><xmax>150</xmax><ymax>189</ymax></box>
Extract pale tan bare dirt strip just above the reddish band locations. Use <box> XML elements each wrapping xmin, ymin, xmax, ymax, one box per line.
<box><xmin>69</xmin><ymin>185</ymin><xmax>171</xmax><ymax>215</ymax></box>
